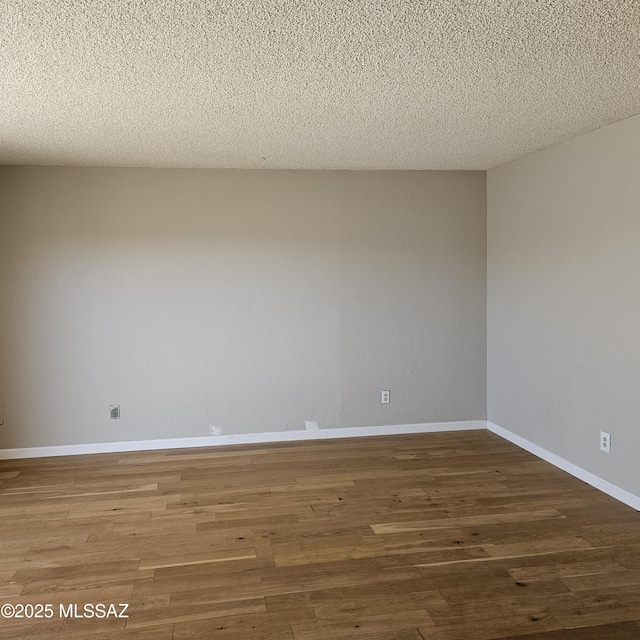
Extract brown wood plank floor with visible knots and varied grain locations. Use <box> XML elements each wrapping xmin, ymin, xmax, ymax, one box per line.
<box><xmin>0</xmin><ymin>431</ymin><xmax>640</xmax><ymax>640</ymax></box>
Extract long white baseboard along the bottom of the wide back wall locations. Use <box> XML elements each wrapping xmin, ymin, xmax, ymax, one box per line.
<box><xmin>0</xmin><ymin>420</ymin><xmax>487</xmax><ymax>460</ymax></box>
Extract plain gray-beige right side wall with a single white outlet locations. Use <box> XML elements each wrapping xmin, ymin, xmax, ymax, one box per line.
<box><xmin>487</xmin><ymin>117</ymin><xmax>640</xmax><ymax>495</ymax></box>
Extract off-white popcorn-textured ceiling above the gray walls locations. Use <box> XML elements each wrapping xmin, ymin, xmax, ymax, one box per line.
<box><xmin>0</xmin><ymin>0</ymin><xmax>640</xmax><ymax>169</ymax></box>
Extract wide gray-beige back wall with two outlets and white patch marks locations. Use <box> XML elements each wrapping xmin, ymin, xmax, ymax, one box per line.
<box><xmin>0</xmin><ymin>167</ymin><xmax>486</xmax><ymax>448</ymax></box>
